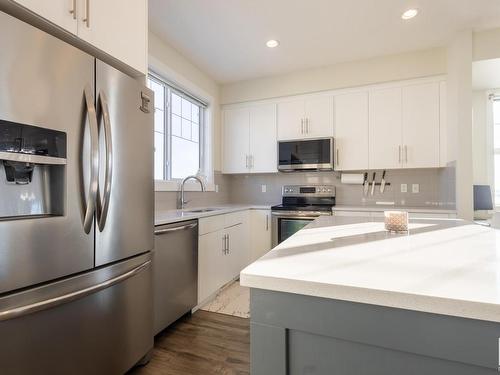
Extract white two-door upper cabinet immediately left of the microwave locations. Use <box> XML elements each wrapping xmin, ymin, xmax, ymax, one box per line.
<box><xmin>222</xmin><ymin>104</ymin><xmax>278</xmax><ymax>173</ymax></box>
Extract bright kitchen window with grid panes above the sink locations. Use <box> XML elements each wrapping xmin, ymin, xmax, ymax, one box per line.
<box><xmin>148</xmin><ymin>73</ymin><xmax>207</xmax><ymax>181</ymax></box>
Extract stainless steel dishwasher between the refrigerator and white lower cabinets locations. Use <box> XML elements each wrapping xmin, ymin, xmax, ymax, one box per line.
<box><xmin>153</xmin><ymin>220</ymin><xmax>198</xmax><ymax>335</ymax></box>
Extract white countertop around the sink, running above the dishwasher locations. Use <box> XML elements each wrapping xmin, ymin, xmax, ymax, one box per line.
<box><xmin>155</xmin><ymin>204</ymin><xmax>271</xmax><ymax>225</ymax></box>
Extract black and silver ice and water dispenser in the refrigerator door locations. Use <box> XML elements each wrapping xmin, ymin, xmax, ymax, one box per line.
<box><xmin>0</xmin><ymin>120</ymin><xmax>66</xmax><ymax>220</ymax></box>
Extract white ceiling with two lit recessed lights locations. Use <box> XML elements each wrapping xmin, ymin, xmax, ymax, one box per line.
<box><xmin>149</xmin><ymin>0</ymin><xmax>500</xmax><ymax>83</ymax></box>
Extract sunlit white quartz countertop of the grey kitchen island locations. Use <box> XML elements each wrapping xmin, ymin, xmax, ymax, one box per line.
<box><xmin>240</xmin><ymin>216</ymin><xmax>500</xmax><ymax>322</ymax></box>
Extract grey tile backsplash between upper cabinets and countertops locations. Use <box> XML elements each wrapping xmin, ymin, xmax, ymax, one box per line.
<box><xmin>155</xmin><ymin>169</ymin><xmax>455</xmax><ymax>210</ymax></box>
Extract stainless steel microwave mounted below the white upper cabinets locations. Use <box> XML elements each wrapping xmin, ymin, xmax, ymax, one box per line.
<box><xmin>278</xmin><ymin>138</ymin><xmax>335</xmax><ymax>172</ymax></box>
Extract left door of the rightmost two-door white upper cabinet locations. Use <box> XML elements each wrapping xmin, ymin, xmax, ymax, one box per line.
<box><xmin>369</xmin><ymin>88</ymin><xmax>402</xmax><ymax>169</ymax></box>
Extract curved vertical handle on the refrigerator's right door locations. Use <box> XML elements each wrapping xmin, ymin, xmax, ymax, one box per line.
<box><xmin>97</xmin><ymin>91</ymin><xmax>113</xmax><ymax>232</ymax></box>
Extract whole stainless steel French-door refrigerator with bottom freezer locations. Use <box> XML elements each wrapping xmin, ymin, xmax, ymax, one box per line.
<box><xmin>0</xmin><ymin>12</ymin><xmax>154</xmax><ymax>374</ymax></box>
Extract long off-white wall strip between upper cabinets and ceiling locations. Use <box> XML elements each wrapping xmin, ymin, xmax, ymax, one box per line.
<box><xmin>221</xmin><ymin>48</ymin><xmax>447</xmax><ymax>104</ymax></box>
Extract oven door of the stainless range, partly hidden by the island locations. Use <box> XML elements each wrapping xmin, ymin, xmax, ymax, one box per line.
<box><xmin>271</xmin><ymin>211</ymin><xmax>325</xmax><ymax>247</ymax></box>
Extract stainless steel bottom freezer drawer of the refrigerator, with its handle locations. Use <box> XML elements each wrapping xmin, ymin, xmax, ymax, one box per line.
<box><xmin>0</xmin><ymin>253</ymin><xmax>153</xmax><ymax>375</ymax></box>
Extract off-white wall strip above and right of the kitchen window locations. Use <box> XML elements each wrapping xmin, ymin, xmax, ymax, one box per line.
<box><xmin>149</xmin><ymin>32</ymin><xmax>221</xmax><ymax>171</ymax></box>
